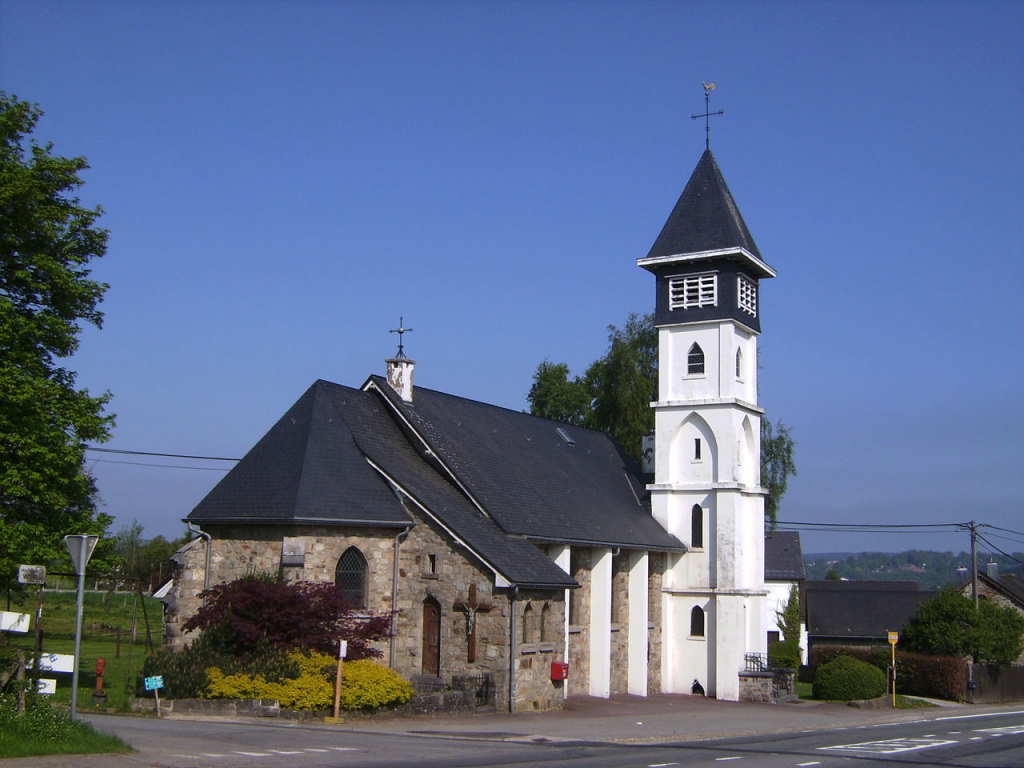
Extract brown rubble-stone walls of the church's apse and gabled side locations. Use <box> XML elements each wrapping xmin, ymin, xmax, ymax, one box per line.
<box><xmin>165</xmin><ymin>509</ymin><xmax>565</xmax><ymax>710</ymax></box>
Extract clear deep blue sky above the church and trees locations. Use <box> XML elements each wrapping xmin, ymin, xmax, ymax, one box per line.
<box><xmin>0</xmin><ymin>0</ymin><xmax>1024</xmax><ymax>552</ymax></box>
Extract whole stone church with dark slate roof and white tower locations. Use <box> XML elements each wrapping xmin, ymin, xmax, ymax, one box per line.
<box><xmin>165</xmin><ymin>144</ymin><xmax>775</xmax><ymax>712</ymax></box>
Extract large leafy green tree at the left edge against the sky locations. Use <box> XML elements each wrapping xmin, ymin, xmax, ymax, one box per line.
<box><xmin>0</xmin><ymin>91</ymin><xmax>113</xmax><ymax>588</ymax></box>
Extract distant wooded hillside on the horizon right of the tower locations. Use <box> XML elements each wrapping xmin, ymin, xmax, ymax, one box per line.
<box><xmin>804</xmin><ymin>550</ymin><xmax>1024</xmax><ymax>590</ymax></box>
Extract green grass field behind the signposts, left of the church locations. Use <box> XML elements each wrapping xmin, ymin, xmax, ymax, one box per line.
<box><xmin>0</xmin><ymin>585</ymin><xmax>163</xmax><ymax>712</ymax></box>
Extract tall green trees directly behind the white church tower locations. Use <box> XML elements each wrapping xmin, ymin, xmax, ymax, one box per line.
<box><xmin>526</xmin><ymin>313</ymin><xmax>797</xmax><ymax>527</ymax></box>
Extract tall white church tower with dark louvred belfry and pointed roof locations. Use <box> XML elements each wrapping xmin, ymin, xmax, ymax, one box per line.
<box><xmin>637</xmin><ymin>148</ymin><xmax>775</xmax><ymax>700</ymax></box>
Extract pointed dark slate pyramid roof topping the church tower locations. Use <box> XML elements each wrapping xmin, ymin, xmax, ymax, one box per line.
<box><xmin>647</xmin><ymin>150</ymin><xmax>761</xmax><ymax>260</ymax></box>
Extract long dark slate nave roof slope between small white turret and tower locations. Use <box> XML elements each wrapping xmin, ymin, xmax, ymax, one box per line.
<box><xmin>371</xmin><ymin>376</ymin><xmax>685</xmax><ymax>552</ymax></box>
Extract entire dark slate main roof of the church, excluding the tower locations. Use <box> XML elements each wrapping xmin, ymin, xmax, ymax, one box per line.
<box><xmin>187</xmin><ymin>377</ymin><xmax>685</xmax><ymax>588</ymax></box>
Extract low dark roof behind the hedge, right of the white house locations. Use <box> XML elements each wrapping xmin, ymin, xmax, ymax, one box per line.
<box><xmin>804</xmin><ymin>582</ymin><xmax>935</xmax><ymax>642</ymax></box>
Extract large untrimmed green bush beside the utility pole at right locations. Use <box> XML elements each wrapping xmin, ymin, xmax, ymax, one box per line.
<box><xmin>903</xmin><ymin>587</ymin><xmax>1024</xmax><ymax>667</ymax></box>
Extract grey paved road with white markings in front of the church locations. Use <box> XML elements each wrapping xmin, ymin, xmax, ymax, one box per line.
<box><xmin>9</xmin><ymin>696</ymin><xmax>1024</xmax><ymax>768</ymax></box>
